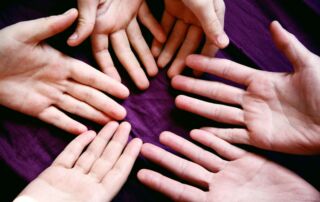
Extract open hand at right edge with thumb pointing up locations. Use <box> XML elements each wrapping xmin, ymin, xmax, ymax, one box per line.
<box><xmin>172</xmin><ymin>22</ymin><xmax>320</xmax><ymax>154</ymax></box>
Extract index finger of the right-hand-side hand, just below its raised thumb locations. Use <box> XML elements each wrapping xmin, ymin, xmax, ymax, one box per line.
<box><xmin>186</xmin><ymin>55</ymin><xmax>258</xmax><ymax>85</ymax></box>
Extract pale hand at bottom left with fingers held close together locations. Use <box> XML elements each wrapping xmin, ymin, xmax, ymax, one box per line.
<box><xmin>16</xmin><ymin>122</ymin><xmax>142</xmax><ymax>202</ymax></box>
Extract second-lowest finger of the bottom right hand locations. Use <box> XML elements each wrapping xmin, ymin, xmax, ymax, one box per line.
<box><xmin>141</xmin><ymin>143</ymin><xmax>212</xmax><ymax>187</ymax></box>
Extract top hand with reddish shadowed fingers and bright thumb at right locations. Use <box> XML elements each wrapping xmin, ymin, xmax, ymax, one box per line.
<box><xmin>151</xmin><ymin>0</ymin><xmax>229</xmax><ymax>78</ymax></box>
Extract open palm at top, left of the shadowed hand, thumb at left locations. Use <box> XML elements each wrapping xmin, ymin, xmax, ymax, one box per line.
<box><xmin>68</xmin><ymin>0</ymin><xmax>166</xmax><ymax>90</ymax></box>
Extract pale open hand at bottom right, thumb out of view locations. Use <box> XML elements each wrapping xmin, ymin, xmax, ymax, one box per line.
<box><xmin>138</xmin><ymin>130</ymin><xmax>320</xmax><ymax>202</ymax></box>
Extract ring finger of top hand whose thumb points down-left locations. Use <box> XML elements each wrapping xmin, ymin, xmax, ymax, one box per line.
<box><xmin>127</xmin><ymin>19</ymin><xmax>158</xmax><ymax>76</ymax></box>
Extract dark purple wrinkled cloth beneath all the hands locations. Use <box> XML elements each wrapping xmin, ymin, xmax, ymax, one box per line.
<box><xmin>0</xmin><ymin>0</ymin><xmax>320</xmax><ymax>201</ymax></box>
